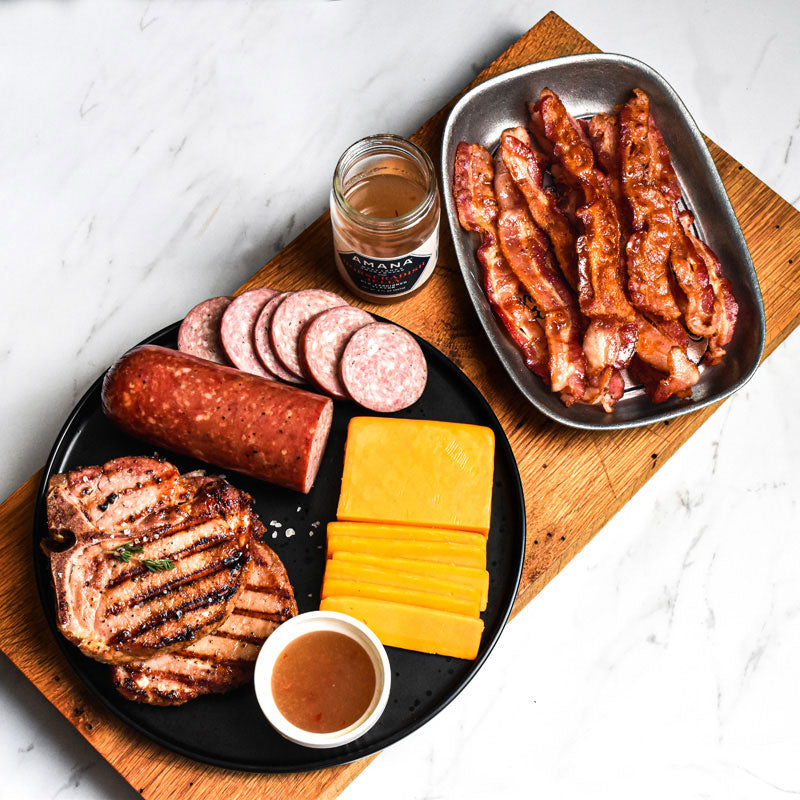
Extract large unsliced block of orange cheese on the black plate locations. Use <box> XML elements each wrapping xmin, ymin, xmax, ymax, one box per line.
<box><xmin>337</xmin><ymin>417</ymin><xmax>494</xmax><ymax>536</ymax></box>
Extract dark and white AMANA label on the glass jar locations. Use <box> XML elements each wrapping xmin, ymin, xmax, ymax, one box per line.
<box><xmin>335</xmin><ymin>225</ymin><xmax>439</xmax><ymax>297</ymax></box>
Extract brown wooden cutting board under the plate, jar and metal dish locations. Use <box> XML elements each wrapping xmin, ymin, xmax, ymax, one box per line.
<box><xmin>0</xmin><ymin>13</ymin><xmax>800</xmax><ymax>800</ymax></box>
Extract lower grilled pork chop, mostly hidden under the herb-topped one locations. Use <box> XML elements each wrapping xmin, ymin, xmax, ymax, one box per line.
<box><xmin>111</xmin><ymin>521</ymin><xmax>297</xmax><ymax>706</ymax></box>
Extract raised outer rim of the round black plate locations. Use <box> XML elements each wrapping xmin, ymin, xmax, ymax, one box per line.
<box><xmin>31</xmin><ymin>314</ymin><xmax>527</xmax><ymax>775</ymax></box>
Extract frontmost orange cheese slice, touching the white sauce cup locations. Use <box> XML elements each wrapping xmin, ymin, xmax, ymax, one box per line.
<box><xmin>320</xmin><ymin>596</ymin><xmax>483</xmax><ymax>659</ymax></box>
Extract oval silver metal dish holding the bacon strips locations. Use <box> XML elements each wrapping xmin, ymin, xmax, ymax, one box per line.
<box><xmin>441</xmin><ymin>53</ymin><xmax>766</xmax><ymax>430</ymax></box>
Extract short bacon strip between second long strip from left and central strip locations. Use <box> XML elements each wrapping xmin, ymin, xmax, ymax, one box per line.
<box><xmin>500</xmin><ymin>128</ymin><xmax>578</xmax><ymax>289</ymax></box>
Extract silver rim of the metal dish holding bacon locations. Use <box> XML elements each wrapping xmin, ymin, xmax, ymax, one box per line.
<box><xmin>439</xmin><ymin>52</ymin><xmax>766</xmax><ymax>431</ymax></box>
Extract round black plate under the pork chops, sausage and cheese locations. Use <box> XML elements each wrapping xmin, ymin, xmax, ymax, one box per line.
<box><xmin>33</xmin><ymin>324</ymin><xmax>525</xmax><ymax>772</ymax></box>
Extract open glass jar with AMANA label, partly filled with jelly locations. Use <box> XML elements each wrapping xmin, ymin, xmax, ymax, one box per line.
<box><xmin>331</xmin><ymin>134</ymin><xmax>440</xmax><ymax>303</ymax></box>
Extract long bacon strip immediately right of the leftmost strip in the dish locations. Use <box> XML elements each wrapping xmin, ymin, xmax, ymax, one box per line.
<box><xmin>494</xmin><ymin>152</ymin><xmax>586</xmax><ymax>405</ymax></box>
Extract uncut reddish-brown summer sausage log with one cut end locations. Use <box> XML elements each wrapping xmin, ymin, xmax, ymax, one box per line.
<box><xmin>103</xmin><ymin>345</ymin><xmax>333</xmax><ymax>492</ymax></box>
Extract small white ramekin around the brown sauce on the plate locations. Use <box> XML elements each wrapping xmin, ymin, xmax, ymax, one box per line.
<box><xmin>254</xmin><ymin>611</ymin><xmax>392</xmax><ymax>748</ymax></box>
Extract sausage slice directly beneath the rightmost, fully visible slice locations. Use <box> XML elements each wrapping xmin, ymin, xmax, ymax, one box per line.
<box><xmin>300</xmin><ymin>306</ymin><xmax>375</xmax><ymax>400</ymax></box>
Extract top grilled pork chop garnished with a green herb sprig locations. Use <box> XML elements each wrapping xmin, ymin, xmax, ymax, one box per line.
<box><xmin>44</xmin><ymin>456</ymin><xmax>256</xmax><ymax>664</ymax></box>
